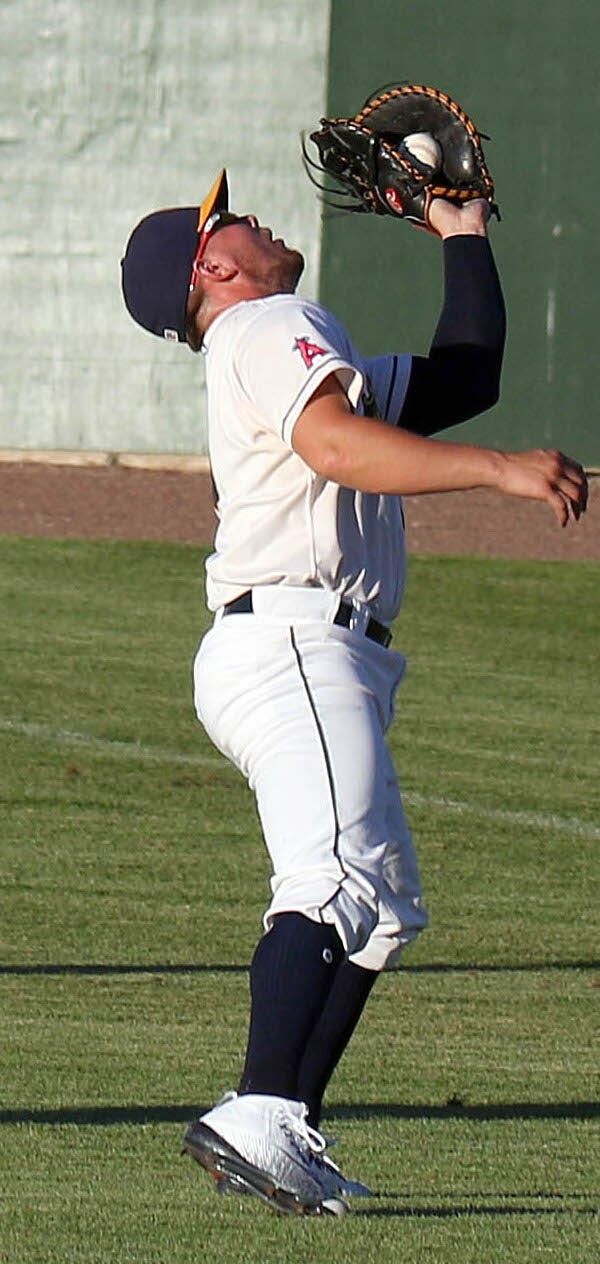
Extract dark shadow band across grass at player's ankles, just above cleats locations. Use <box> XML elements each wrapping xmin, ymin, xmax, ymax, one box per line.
<box><xmin>0</xmin><ymin>1100</ymin><xmax>600</xmax><ymax>1127</ymax></box>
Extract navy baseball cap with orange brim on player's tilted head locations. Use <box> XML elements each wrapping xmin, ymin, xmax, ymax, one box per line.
<box><xmin>121</xmin><ymin>171</ymin><xmax>229</xmax><ymax>343</ymax></box>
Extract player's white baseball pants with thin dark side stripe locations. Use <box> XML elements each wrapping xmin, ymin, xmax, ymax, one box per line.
<box><xmin>195</xmin><ymin>586</ymin><xmax>427</xmax><ymax>971</ymax></box>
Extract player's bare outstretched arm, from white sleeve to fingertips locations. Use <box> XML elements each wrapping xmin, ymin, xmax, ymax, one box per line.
<box><xmin>292</xmin><ymin>375</ymin><xmax>587</xmax><ymax>526</ymax></box>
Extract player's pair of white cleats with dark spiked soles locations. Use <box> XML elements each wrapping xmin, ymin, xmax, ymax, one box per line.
<box><xmin>183</xmin><ymin>1093</ymin><xmax>368</xmax><ymax>1216</ymax></box>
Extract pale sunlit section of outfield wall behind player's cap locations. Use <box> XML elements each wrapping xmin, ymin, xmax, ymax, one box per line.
<box><xmin>0</xmin><ymin>0</ymin><xmax>330</xmax><ymax>453</ymax></box>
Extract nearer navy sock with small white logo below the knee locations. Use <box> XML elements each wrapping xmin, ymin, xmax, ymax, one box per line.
<box><xmin>240</xmin><ymin>913</ymin><xmax>344</xmax><ymax>1098</ymax></box>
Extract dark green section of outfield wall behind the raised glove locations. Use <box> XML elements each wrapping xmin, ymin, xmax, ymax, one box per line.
<box><xmin>321</xmin><ymin>0</ymin><xmax>600</xmax><ymax>465</ymax></box>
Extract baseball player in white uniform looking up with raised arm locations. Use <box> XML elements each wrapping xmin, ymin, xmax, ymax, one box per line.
<box><xmin>123</xmin><ymin>172</ymin><xmax>587</xmax><ymax>1213</ymax></box>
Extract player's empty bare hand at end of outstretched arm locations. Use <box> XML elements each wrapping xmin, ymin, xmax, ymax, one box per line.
<box><xmin>498</xmin><ymin>447</ymin><xmax>587</xmax><ymax>527</ymax></box>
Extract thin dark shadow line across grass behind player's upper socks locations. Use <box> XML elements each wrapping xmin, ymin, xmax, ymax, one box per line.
<box><xmin>0</xmin><ymin>961</ymin><xmax>600</xmax><ymax>980</ymax></box>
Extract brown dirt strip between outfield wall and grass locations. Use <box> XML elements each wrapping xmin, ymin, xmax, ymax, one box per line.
<box><xmin>0</xmin><ymin>461</ymin><xmax>600</xmax><ymax>561</ymax></box>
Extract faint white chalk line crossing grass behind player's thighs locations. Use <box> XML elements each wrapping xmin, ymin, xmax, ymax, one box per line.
<box><xmin>0</xmin><ymin>719</ymin><xmax>600</xmax><ymax>839</ymax></box>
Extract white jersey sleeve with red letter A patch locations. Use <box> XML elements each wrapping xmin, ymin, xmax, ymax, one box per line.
<box><xmin>235</xmin><ymin>303</ymin><xmax>364</xmax><ymax>447</ymax></box>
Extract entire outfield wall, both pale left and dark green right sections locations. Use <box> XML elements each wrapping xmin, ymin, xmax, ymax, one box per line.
<box><xmin>0</xmin><ymin>0</ymin><xmax>600</xmax><ymax>465</ymax></box>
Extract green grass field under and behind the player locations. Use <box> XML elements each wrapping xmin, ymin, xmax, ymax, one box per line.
<box><xmin>0</xmin><ymin>538</ymin><xmax>600</xmax><ymax>1264</ymax></box>
